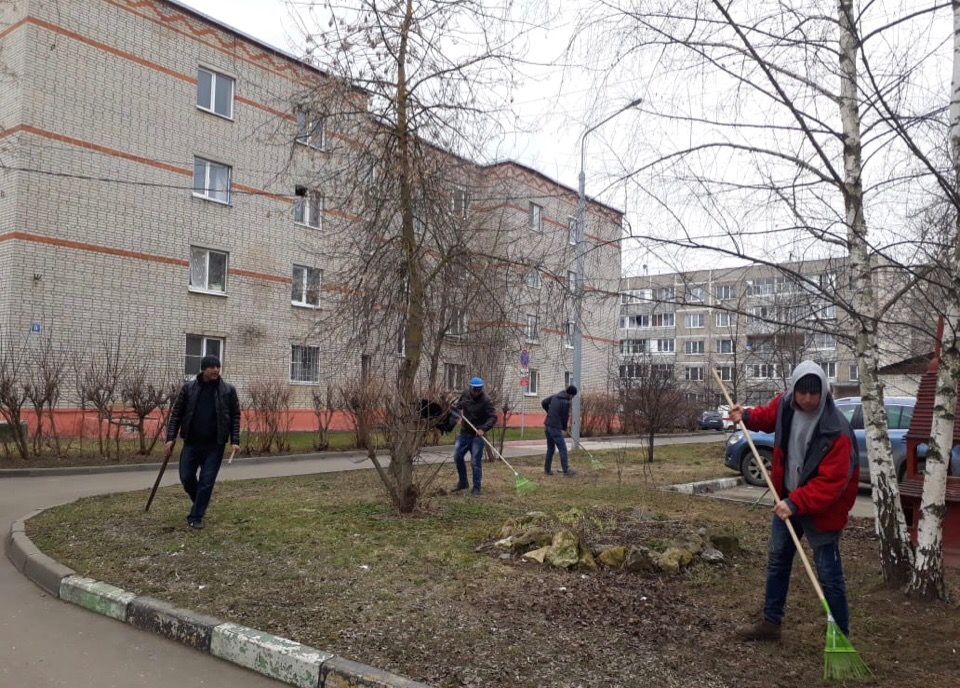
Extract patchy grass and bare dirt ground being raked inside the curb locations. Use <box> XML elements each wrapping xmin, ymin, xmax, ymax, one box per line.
<box><xmin>16</xmin><ymin>446</ymin><xmax>960</xmax><ymax>688</ymax></box>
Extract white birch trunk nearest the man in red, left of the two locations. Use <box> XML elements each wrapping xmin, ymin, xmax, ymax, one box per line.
<box><xmin>839</xmin><ymin>0</ymin><xmax>913</xmax><ymax>588</ymax></box>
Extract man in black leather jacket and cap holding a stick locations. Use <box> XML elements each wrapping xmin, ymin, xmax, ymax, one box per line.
<box><xmin>166</xmin><ymin>356</ymin><xmax>240</xmax><ymax>530</ymax></box>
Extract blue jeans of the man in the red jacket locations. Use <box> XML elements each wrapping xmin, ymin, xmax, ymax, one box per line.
<box><xmin>763</xmin><ymin>516</ymin><xmax>850</xmax><ymax>636</ymax></box>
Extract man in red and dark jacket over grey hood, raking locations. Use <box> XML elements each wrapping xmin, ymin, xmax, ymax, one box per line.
<box><xmin>730</xmin><ymin>361</ymin><xmax>860</xmax><ymax>640</ymax></box>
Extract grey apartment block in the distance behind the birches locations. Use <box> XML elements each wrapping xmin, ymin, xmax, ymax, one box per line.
<box><xmin>618</xmin><ymin>259</ymin><xmax>924</xmax><ymax>407</ymax></box>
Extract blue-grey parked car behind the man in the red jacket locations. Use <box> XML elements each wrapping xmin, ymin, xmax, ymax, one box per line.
<box><xmin>723</xmin><ymin>397</ymin><xmax>960</xmax><ymax>487</ymax></box>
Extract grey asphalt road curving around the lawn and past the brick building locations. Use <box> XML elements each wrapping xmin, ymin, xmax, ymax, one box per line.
<box><xmin>0</xmin><ymin>430</ymin><xmax>724</xmax><ymax>688</ymax></box>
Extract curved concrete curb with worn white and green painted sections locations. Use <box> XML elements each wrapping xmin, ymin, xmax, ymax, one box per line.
<box><xmin>7</xmin><ymin>509</ymin><xmax>430</xmax><ymax>688</ymax></box>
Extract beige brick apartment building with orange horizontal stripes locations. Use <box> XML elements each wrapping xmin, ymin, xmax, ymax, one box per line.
<box><xmin>0</xmin><ymin>0</ymin><xmax>622</xmax><ymax>422</ymax></box>
